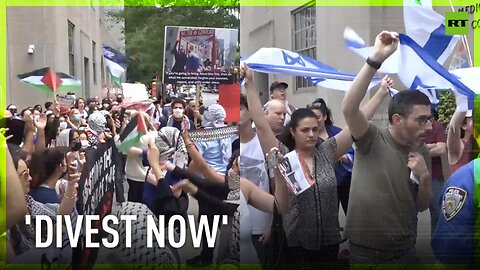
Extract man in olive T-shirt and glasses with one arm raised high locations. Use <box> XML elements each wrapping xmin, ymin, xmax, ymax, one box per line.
<box><xmin>342</xmin><ymin>31</ymin><xmax>433</xmax><ymax>264</ymax></box>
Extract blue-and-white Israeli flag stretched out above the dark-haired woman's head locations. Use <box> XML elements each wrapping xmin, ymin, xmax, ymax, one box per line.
<box><xmin>242</xmin><ymin>48</ymin><xmax>381</xmax><ymax>91</ymax></box>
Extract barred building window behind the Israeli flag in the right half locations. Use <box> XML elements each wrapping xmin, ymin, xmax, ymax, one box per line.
<box><xmin>292</xmin><ymin>6</ymin><xmax>317</xmax><ymax>89</ymax></box>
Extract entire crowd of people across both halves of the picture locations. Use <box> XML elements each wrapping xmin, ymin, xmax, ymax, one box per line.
<box><xmin>1</xmin><ymin>31</ymin><xmax>478</xmax><ymax>266</ymax></box>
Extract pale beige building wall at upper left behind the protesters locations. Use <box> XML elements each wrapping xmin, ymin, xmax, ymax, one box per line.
<box><xmin>7</xmin><ymin>7</ymin><xmax>123</xmax><ymax>109</ymax></box>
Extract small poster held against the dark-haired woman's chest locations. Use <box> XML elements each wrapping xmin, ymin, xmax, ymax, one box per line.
<box><xmin>278</xmin><ymin>151</ymin><xmax>314</xmax><ymax>195</ymax></box>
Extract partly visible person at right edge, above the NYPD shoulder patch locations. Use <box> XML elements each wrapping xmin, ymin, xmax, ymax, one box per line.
<box><xmin>447</xmin><ymin>110</ymin><xmax>478</xmax><ymax>173</ymax></box>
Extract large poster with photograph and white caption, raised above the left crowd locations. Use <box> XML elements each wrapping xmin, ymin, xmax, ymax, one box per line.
<box><xmin>163</xmin><ymin>26</ymin><xmax>238</xmax><ymax>85</ymax></box>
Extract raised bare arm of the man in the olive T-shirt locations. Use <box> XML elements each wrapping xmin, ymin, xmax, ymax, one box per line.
<box><xmin>342</xmin><ymin>31</ymin><xmax>399</xmax><ymax>139</ymax></box>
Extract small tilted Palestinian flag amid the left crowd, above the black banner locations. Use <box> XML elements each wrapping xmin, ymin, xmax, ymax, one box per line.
<box><xmin>118</xmin><ymin>113</ymin><xmax>147</xmax><ymax>154</ymax></box>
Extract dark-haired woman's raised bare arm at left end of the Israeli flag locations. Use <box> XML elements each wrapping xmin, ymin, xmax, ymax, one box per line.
<box><xmin>240</xmin><ymin>65</ymin><xmax>278</xmax><ymax>153</ymax></box>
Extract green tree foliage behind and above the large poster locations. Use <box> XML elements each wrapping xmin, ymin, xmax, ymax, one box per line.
<box><xmin>109</xmin><ymin>0</ymin><xmax>240</xmax><ymax>82</ymax></box>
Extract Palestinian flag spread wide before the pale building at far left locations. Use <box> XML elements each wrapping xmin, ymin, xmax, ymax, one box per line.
<box><xmin>17</xmin><ymin>67</ymin><xmax>82</xmax><ymax>93</ymax></box>
